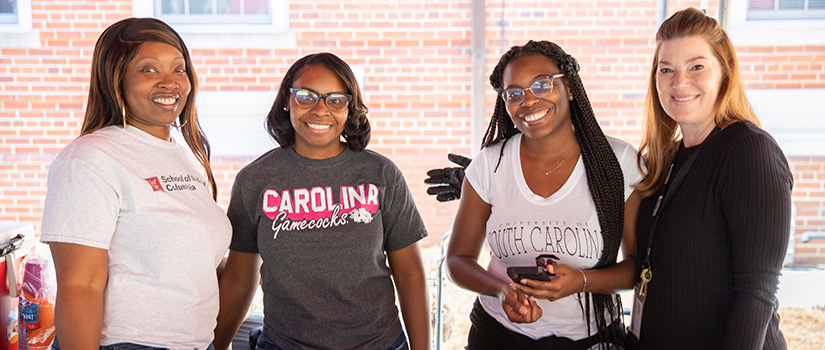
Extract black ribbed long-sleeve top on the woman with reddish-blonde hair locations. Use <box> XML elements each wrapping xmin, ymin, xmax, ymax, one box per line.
<box><xmin>636</xmin><ymin>122</ymin><xmax>793</xmax><ymax>350</ymax></box>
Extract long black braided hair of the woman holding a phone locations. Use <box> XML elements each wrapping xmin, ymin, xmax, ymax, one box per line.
<box><xmin>481</xmin><ymin>40</ymin><xmax>624</xmax><ymax>345</ymax></box>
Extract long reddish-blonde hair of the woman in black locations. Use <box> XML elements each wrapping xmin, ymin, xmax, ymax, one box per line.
<box><xmin>634</xmin><ymin>8</ymin><xmax>760</xmax><ymax>196</ymax></box>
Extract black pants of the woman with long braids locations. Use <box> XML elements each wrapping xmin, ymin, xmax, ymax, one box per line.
<box><xmin>467</xmin><ymin>299</ymin><xmax>625</xmax><ymax>350</ymax></box>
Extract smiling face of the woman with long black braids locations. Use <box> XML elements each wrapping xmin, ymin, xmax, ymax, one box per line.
<box><xmin>502</xmin><ymin>55</ymin><xmax>572</xmax><ymax>139</ymax></box>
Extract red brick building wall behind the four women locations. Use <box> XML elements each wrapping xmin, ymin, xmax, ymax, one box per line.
<box><xmin>0</xmin><ymin>0</ymin><xmax>825</xmax><ymax>264</ymax></box>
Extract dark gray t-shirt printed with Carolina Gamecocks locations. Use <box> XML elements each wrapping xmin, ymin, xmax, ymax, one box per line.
<box><xmin>228</xmin><ymin>148</ymin><xmax>427</xmax><ymax>349</ymax></box>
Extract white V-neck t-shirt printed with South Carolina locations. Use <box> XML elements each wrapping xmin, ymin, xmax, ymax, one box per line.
<box><xmin>466</xmin><ymin>134</ymin><xmax>642</xmax><ymax>340</ymax></box>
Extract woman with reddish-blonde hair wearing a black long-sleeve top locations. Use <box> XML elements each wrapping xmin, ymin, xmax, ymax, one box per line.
<box><xmin>631</xmin><ymin>8</ymin><xmax>793</xmax><ymax>349</ymax></box>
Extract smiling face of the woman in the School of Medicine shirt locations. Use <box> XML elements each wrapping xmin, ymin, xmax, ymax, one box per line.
<box><xmin>123</xmin><ymin>41</ymin><xmax>191</xmax><ymax>140</ymax></box>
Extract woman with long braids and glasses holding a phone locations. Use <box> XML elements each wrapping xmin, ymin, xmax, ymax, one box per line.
<box><xmin>447</xmin><ymin>41</ymin><xmax>641</xmax><ymax>350</ymax></box>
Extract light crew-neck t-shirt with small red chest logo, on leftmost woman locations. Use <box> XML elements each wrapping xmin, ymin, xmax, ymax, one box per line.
<box><xmin>40</xmin><ymin>126</ymin><xmax>232</xmax><ymax>350</ymax></box>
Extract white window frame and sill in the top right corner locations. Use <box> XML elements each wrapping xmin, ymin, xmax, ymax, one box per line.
<box><xmin>726</xmin><ymin>0</ymin><xmax>825</xmax><ymax>46</ymax></box>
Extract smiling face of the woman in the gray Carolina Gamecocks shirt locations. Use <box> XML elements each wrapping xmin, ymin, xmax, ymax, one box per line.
<box><xmin>289</xmin><ymin>65</ymin><xmax>349</xmax><ymax>159</ymax></box>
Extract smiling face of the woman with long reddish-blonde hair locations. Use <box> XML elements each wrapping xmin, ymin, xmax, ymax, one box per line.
<box><xmin>656</xmin><ymin>36</ymin><xmax>722</xmax><ymax>136</ymax></box>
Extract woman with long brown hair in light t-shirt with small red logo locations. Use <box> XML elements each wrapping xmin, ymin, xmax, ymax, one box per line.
<box><xmin>40</xmin><ymin>18</ymin><xmax>231</xmax><ymax>349</ymax></box>
